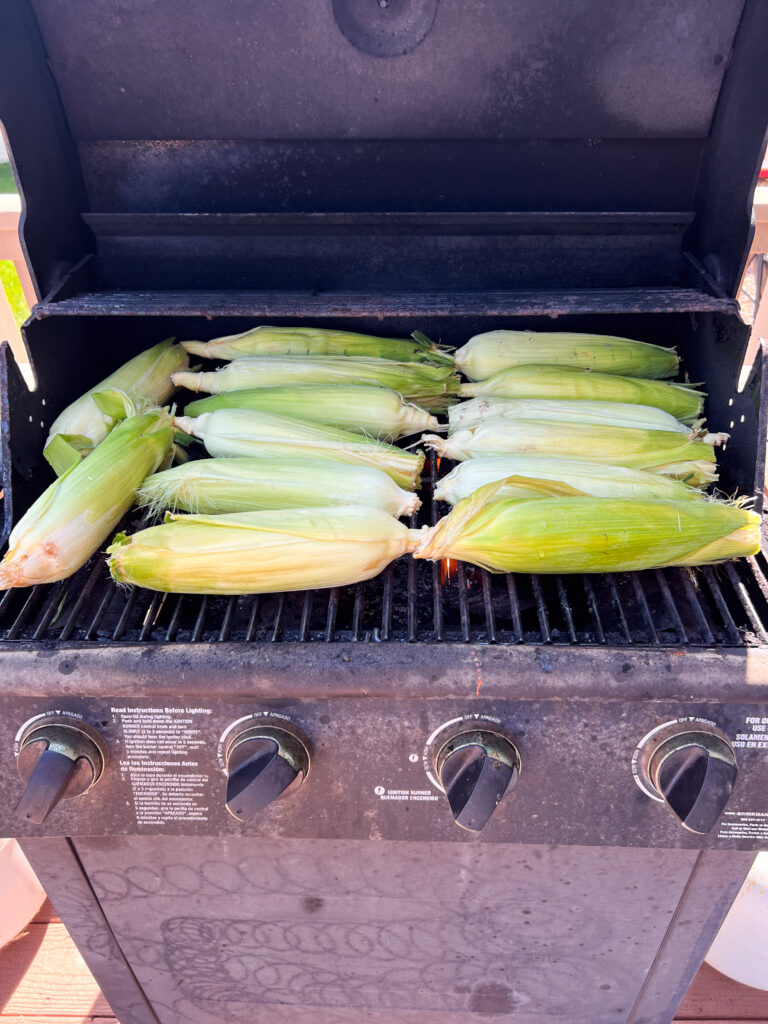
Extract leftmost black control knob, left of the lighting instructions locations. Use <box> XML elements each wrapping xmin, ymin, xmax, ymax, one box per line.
<box><xmin>16</xmin><ymin>718</ymin><xmax>109</xmax><ymax>825</ymax></box>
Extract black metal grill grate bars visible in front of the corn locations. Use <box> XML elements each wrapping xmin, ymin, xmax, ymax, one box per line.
<box><xmin>0</xmin><ymin>458</ymin><xmax>768</xmax><ymax>647</ymax></box>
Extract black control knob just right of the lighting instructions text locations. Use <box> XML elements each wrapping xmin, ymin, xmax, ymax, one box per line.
<box><xmin>224</xmin><ymin>719</ymin><xmax>309</xmax><ymax>821</ymax></box>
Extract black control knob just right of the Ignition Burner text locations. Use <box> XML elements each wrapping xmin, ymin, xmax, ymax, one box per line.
<box><xmin>435</xmin><ymin>729</ymin><xmax>520</xmax><ymax>831</ymax></box>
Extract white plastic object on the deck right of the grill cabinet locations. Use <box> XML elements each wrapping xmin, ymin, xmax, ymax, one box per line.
<box><xmin>706</xmin><ymin>853</ymin><xmax>768</xmax><ymax>991</ymax></box>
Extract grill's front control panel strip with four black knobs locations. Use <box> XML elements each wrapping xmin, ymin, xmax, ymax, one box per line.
<box><xmin>0</xmin><ymin>697</ymin><xmax>768</xmax><ymax>849</ymax></box>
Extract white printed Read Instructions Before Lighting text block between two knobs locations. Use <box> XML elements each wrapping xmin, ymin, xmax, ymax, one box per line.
<box><xmin>111</xmin><ymin>707</ymin><xmax>211</xmax><ymax>825</ymax></box>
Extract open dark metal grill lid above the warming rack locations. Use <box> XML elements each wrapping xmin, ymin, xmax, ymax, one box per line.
<box><xmin>0</xmin><ymin>0</ymin><xmax>768</xmax><ymax>293</ymax></box>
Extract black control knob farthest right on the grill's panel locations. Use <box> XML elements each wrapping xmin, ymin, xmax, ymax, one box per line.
<box><xmin>648</xmin><ymin>729</ymin><xmax>738</xmax><ymax>835</ymax></box>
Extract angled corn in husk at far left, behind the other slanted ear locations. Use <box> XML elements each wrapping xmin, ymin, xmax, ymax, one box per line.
<box><xmin>43</xmin><ymin>338</ymin><xmax>189</xmax><ymax>475</ymax></box>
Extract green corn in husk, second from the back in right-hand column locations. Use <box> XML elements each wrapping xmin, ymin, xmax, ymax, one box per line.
<box><xmin>459</xmin><ymin>366</ymin><xmax>703</xmax><ymax>423</ymax></box>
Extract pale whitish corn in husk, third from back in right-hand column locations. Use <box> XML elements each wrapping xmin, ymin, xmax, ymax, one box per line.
<box><xmin>447</xmin><ymin>398</ymin><xmax>690</xmax><ymax>434</ymax></box>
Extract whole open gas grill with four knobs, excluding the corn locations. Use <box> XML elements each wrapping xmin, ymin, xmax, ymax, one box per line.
<box><xmin>0</xmin><ymin>0</ymin><xmax>768</xmax><ymax>1024</ymax></box>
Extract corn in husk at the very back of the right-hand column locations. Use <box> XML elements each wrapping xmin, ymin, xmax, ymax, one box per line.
<box><xmin>454</xmin><ymin>331</ymin><xmax>679</xmax><ymax>381</ymax></box>
